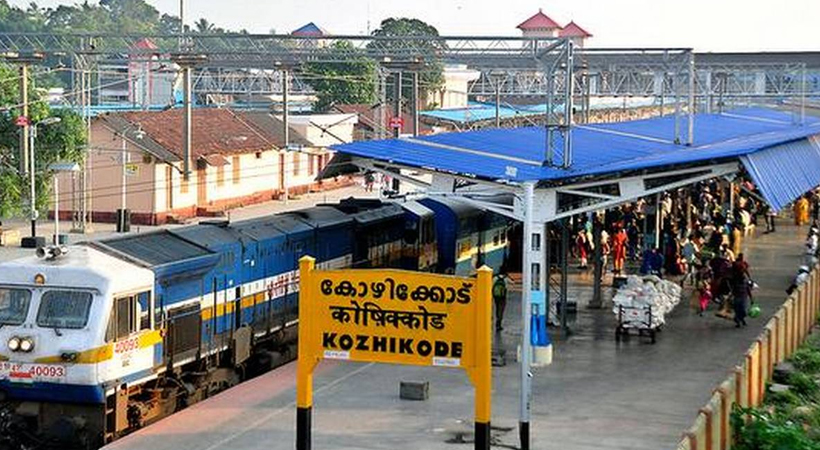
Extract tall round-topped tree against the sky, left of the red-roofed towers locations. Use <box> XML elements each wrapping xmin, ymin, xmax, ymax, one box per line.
<box><xmin>368</xmin><ymin>18</ymin><xmax>447</xmax><ymax>107</ymax></box>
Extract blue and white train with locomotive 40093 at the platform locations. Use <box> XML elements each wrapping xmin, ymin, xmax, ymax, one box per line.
<box><xmin>0</xmin><ymin>198</ymin><xmax>514</xmax><ymax>448</ymax></box>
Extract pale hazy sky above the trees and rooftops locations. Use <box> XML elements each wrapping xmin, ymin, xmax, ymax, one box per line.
<box><xmin>10</xmin><ymin>0</ymin><xmax>820</xmax><ymax>51</ymax></box>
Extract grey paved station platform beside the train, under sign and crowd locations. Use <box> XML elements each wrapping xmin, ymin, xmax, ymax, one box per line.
<box><xmin>105</xmin><ymin>220</ymin><xmax>807</xmax><ymax>450</ymax></box>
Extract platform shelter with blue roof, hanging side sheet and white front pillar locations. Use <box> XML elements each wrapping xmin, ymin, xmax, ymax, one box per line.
<box><xmin>323</xmin><ymin>108</ymin><xmax>820</xmax><ymax>448</ymax></box>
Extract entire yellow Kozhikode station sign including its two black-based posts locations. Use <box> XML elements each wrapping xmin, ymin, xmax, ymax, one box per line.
<box><xmin>296</xmin><ymin>256</ymin><xmax>492</xmax><ymax>450</ymax></box>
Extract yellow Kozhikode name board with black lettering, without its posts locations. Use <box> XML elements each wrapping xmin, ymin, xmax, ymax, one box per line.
<box><xmin>311</xmin><ymin>270</ymin><xmax>477</xmax><ymax>368</ymax></box>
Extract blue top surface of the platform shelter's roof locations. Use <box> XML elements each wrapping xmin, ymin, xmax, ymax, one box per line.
<box><xmin>333</xmin><ymin>109</ymin><xmax>820</xmax><ymax>182</ymax></box>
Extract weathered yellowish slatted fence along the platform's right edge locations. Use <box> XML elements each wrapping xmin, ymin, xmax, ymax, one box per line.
<box><xmin>676</xmin><ymin>266</ymin><xmax>820</xmax><ymax>450</ymax></box>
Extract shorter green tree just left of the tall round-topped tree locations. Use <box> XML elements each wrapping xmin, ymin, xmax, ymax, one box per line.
<box><xmin>304</xmin><ymin>41</ymin><xmax>378</xmax><ymax>111</ymax></box>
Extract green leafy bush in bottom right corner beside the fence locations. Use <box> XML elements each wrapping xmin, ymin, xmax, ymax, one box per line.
<box><xmin>731</xmin><ymin>407</ymin><xmax>820</xmax><ymax>450</ymax></box>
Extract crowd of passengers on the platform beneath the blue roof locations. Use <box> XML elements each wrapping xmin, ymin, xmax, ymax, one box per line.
<box><xmin>572</xmin><ymin>181</ymin><xmax>820</xmax><ymax>328</ymax></box>
